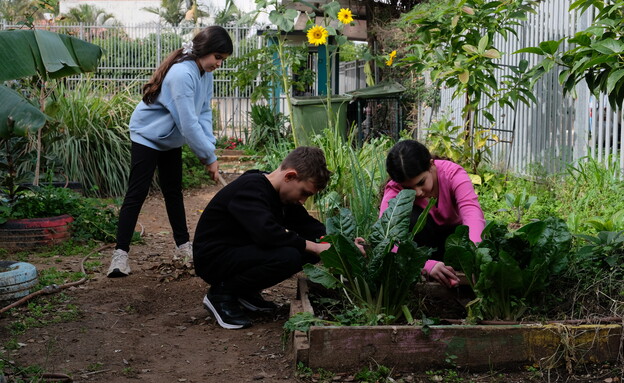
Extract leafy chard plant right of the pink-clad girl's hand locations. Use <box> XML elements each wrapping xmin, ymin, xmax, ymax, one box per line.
<box><xmin>444</xmin><ymin>217</ymin><xmax>572</xmax><ymax>321</ymax></box>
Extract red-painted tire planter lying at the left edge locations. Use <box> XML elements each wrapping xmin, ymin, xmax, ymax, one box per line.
<box><xmin>0</xmin><ymin>214</ymin><xmax>74</xmax><ymax>250</ymax></box>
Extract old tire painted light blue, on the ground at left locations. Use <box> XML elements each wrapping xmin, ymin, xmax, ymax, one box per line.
<box><xmin>0</xmin><ymin>261</ymin><xmax>38</xmax><ymax>301</ymax></box>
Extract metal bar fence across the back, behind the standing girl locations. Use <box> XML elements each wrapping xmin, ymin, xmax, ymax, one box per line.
<box><xmin>0</xmin><ymin>20</ymin><xmax>365</xmax><ymax>142</ymax></box>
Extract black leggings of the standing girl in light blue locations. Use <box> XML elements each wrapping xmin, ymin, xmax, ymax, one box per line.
<box><xmin>115</xmin><ymin>142</ymin><xmax>190</xmax><ymax>251</ymax></box>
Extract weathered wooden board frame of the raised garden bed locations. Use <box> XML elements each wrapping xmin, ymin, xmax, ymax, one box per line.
<box><xmin>290</xmin><ymin>278</ymin><xmax>624</xmax><ymax>372</ymax></box>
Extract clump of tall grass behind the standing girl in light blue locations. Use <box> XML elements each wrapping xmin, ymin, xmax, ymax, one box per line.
<box><xmin>44</xmin><ymin>79</ymin><xmax>138</xmax><ymax>197</ymax></box>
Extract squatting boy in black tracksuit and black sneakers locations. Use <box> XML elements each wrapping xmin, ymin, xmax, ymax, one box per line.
<box><xmin>193</xmin><ymin>147</ymin><xmax>330</xmax><ymax>329</ymax></box>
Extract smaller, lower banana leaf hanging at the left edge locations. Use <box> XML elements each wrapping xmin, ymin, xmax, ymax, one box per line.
<box><xmin>0</xmin><ymin>85</ymin><xmax>46</xmax><ymax>138</ymax></box>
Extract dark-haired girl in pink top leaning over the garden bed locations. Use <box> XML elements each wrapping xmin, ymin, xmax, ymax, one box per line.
<box><xmin>379</xmin><ymin>140</ymin><xmax>485</xmax><ymax>287</ymax></box>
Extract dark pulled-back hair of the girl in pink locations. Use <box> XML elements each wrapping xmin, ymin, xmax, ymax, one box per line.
<box><xmin>386</xmin><ymin>140</ymin><xmax>432</xmax><ymax>183</ymax></box>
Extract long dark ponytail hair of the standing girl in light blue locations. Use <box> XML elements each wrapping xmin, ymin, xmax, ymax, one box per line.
<box><xmin>143</xmin><ymin>25</ymin><xmax>234</xmax><ymax>104</ymax></box>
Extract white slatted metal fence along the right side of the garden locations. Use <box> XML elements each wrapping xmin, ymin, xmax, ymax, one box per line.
<box><xmin>418</xmin><ymin>0</ymin><xmax>624</xmax><ymax>174</ymax></box>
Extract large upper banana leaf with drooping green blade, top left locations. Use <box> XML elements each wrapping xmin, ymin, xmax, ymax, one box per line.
<box><xmin>0</xmin><ymin>30</ymin><xmax>102</xmax><ymax>81</ymax></box>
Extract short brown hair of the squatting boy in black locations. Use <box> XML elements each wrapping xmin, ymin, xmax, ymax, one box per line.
<box><xmin>280</xmin><ymin>146</ymin><xmax>331</xmax><ymax>190</ymax></box>
